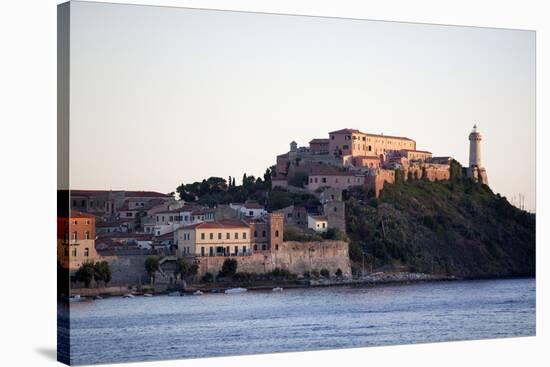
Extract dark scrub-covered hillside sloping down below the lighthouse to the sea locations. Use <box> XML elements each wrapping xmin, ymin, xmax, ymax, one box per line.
<box><xmin>346</xmin><ymin>178</ymin><xmax>535</xmax><ymax>277</ymax></box>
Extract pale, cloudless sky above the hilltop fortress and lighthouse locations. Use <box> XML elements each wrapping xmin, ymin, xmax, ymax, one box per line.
<box><xmin>70</xmin><ymin>2</ymin><xmax>535</xmax><ymax>210</ymax></box>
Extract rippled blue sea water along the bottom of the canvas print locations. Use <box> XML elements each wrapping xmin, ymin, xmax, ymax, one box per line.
<box><xmin>67</xmin><ymin>279</ymin><xmax>535</xmax><ymax>364</ymax></box>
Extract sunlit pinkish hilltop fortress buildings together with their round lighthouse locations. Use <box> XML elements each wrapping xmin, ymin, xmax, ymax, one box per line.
<box><xmin>272</xmin><ymin>125</ymin><xmax>488</xmax><ymax>197</ymax></box>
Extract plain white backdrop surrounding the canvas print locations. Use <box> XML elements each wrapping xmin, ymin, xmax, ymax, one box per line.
<box><xmin>0</xmin><ymin>0</ymin><xmax>550</xmax><ymax>367</ymax></box>
